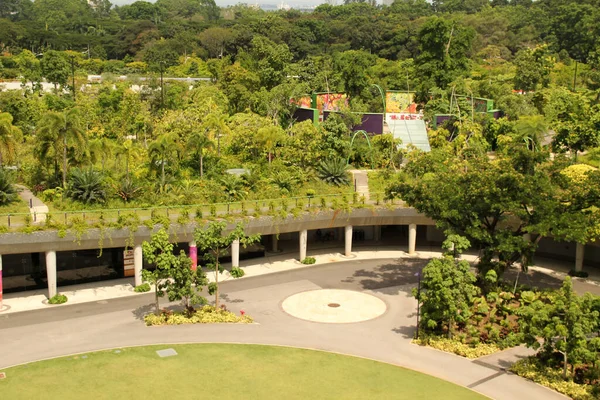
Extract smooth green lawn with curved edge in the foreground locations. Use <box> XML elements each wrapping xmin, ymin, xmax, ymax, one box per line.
<box><xmin>0</xmin><ymin>344</ymin><xmax>485</xmax><ymax>400</ymax></box>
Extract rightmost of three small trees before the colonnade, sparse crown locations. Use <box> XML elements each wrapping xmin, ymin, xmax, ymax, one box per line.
<box><xmin>194</xmin><ymin>221</ymin><xmax>260</xmax><ymax>308</ymax></box>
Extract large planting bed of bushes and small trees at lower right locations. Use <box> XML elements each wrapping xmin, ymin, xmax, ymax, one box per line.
<box><xmin>413</xmin><ymin>235</ymin><xmax>600</xmax><ymax>400</ymax></box>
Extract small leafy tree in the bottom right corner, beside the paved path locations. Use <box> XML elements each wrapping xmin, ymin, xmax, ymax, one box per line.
<box><xmin>518</xmin><ymin>276</ymin><xmax>600</xmax><ymax>379</ymax></box>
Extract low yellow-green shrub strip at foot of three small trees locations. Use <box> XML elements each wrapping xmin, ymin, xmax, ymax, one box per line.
<box><xmin>144</xmin><ymin>305</ymin><xmax>254</xmax><ymax>326</ymax></box>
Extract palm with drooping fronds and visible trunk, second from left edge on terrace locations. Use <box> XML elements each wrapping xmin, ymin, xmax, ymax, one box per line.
<box><xmin>38</xmin><ymin>108</ymin><xmax>87</xmax><ymax>188</ymax></box>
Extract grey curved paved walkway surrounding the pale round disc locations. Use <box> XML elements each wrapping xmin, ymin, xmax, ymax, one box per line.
<box><xmin>0</xmin><ymin>248</ymin><xmax>600</xmax><ymax>400</ymax></box>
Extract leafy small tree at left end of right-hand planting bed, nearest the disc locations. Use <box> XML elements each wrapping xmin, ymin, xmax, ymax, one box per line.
<box><xmin>413</xmin><ymin>253</ymin><xmax>478</xmax><ymax>337</ymax></box>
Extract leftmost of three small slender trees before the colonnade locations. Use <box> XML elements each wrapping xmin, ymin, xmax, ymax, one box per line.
<box><xmin>142</xmin><ymin>228</ymin><xmax>178</xmax><ymax>314</ymax></box>
